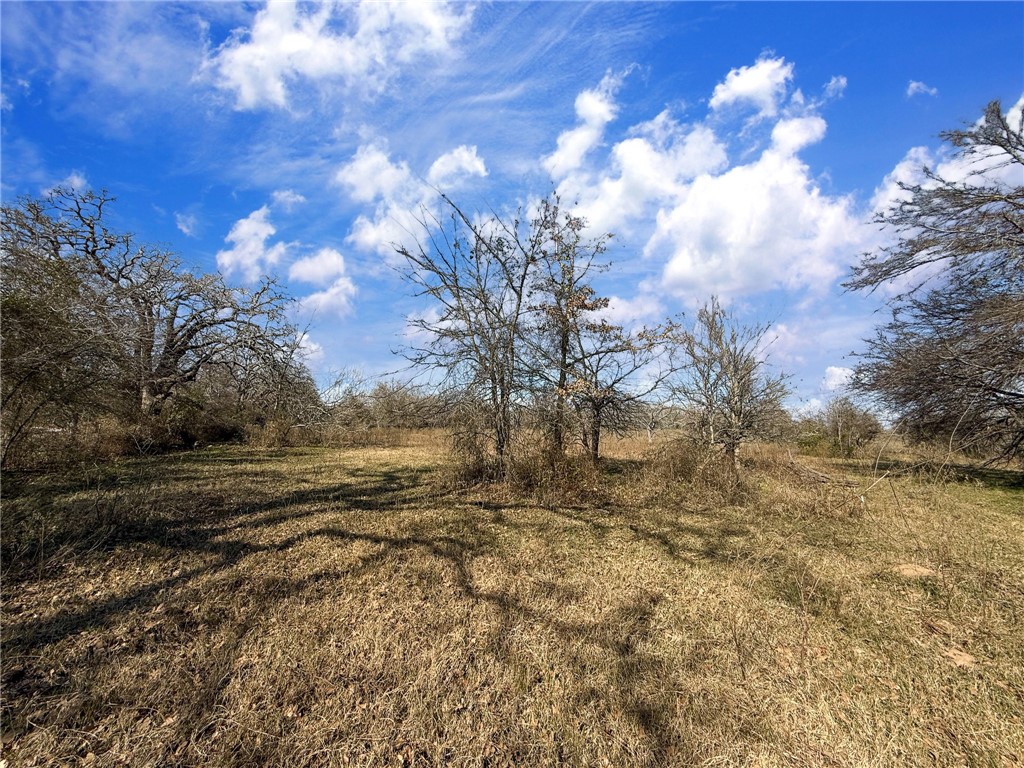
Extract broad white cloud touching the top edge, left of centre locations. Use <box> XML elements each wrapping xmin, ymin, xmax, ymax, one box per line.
<box><xmin>206</xmin><ymin>0</ymin><xmax>473</xmax><ymax>110</ymax></box>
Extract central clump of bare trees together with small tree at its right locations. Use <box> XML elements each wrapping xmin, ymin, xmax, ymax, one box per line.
<box><xmin>398</xmin><ymin>197</ymin><xmax>785</xmax><ymax>475</ymax></box>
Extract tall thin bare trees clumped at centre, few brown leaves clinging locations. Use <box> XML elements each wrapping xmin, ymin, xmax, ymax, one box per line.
<box><xmin>398</xmin><ymin>196</ymin><xmax>679</xmax><ymax>464</ymax></box>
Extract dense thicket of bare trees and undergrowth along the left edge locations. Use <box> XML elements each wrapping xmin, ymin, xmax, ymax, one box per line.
<box><xmin>0</xmin><ymin>188</ymin><xmax>316</xmax><ymax>466</ymax></box>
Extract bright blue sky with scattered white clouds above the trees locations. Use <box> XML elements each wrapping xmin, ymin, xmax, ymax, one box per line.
<box><xmin>0</xmin><ymin>0</ymin><xmax>1024</xmax><ymax>404</ymax></box>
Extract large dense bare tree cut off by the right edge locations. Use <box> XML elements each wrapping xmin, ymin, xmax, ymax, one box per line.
<box><xmin>847</xmin><ymin>101</ymin><xmax>1024</xmax><ymax>458</ymax></box>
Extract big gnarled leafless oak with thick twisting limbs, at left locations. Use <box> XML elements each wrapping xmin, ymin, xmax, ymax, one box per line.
<box><xmin>40</xmin><ymin>189</ymin><xmax>296</xmax><ymax>416</ymax></box>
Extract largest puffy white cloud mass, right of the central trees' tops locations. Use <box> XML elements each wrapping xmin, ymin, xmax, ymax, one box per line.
<box><xmin>544</xmin><ymin>56</ymin><xmax>869</xmax><ymax>304</ymax></box>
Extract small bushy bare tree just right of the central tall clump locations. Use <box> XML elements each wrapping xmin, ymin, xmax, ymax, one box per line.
<box><xmin>670</xmin><ymin>298</ymin><xmax>787</xmax><ymax>473</ymax></box>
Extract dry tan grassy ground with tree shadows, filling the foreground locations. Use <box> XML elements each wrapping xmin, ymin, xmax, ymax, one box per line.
<box><xmin>2</xmin><ymin>442</ymin><xmax>1024</xmax><ymax>766</ymax></box>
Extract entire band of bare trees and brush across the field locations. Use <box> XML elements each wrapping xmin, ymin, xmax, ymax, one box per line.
<box><xmin>0</xmin><ymin>102</ymin><xmax>1024</xmax><ymax>477</ymax></box>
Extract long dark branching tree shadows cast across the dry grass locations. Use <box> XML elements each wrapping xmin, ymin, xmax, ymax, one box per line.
<box><xmin>4</xmin><ymin>448</ymin><xmax>774</xmax><ymax>765</ymax></box>
